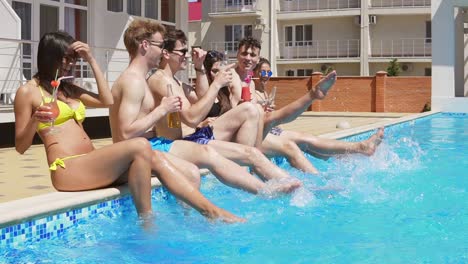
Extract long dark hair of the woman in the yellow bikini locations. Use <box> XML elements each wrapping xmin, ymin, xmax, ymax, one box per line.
<box><xmin>34</xmin><ymin>31</ymin><xmax>76</xmax><ymax>97</ymax></box>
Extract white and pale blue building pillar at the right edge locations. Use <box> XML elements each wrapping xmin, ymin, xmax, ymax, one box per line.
<box><xmin>431</xmin><ymin>0</ymin><xmax>468</xmax><ymax>113</ymax></box>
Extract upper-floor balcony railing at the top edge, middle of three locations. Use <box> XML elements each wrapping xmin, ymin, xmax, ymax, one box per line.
<box><xmin>280</xmin><ymin>0</ymin><xmax>361</xmax><ymax>12</ymax></box>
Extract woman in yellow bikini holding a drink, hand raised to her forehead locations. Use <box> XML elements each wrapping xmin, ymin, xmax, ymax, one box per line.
<box><xmin>15</xmin><ymin>32</ymin><xmax>153</xmax><ymax>218</ymax></box>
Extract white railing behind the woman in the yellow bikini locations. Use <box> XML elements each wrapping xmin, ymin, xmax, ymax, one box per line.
<box><xmin>0</xmin><ymin>38</ymin><xmax>129</xmax><ymax>105</ymax></box>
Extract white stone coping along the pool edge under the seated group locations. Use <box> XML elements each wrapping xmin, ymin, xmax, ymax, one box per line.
<box><xmin>0</xmin><ymin>111</ymin><xmax>438</xmax><ymax>228</ymax></box>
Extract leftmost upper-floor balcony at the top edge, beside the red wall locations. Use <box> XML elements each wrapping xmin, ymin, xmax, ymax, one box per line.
<box><xmin>208</xmin><ymin>0</ymin><xmax>260</xmax><ymax>17</ymax></box>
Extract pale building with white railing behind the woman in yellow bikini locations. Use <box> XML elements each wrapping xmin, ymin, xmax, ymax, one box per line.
<box><xmin>0</xmin><ymin>0</ymin><xmax>188</xmax><ymax>120</ymax></box>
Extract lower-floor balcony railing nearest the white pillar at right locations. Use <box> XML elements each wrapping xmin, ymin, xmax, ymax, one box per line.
<box><xmin>371</xmin><ymin>38</ymin><xmax>432</xmax><ymax>58</ymax></box>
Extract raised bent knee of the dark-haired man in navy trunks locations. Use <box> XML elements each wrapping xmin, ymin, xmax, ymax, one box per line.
<box><xmin>212</xmin><ymin>103</ymin><xmax>261</xmax><ymax>146</ymax></box>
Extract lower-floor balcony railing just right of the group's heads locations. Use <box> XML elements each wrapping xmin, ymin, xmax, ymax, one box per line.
<box><xmin>280</xmin><ymin>39</ymin><xmax>360</xmax><ymax>59</ymax></box>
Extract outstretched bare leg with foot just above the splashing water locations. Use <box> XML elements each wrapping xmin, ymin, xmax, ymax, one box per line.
<box><xmin>280</xmin><ymin>128</ymin><xmax>384</xmax><ymax>156</ymax></box>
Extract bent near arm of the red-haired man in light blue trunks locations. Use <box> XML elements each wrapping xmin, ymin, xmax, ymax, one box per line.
<box><xmin>118</xmin><ymin>77</ymin><xmax>176</xmax><ymax>139</ymax></box>
